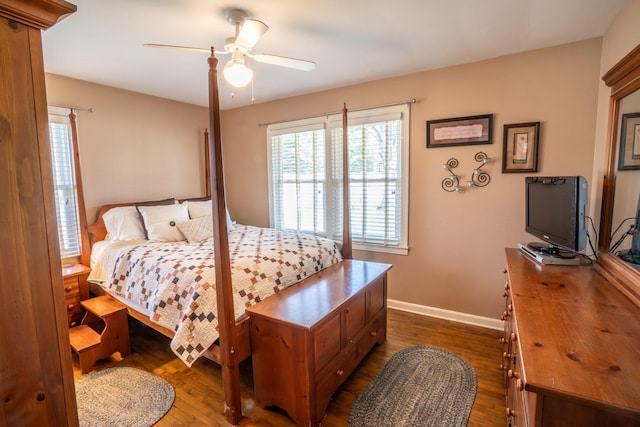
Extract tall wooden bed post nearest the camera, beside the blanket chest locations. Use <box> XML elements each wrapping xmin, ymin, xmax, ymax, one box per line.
<box><xmin>208</xmin><ymin>48</ymin><xmax>242</xmax><ymax>424</ymax></box>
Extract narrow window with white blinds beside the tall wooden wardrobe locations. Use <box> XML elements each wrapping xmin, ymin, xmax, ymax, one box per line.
<box><xmin>49</xmin><ymin>107</ymin><xmax>81</xmax><ymax>258</ymax></box>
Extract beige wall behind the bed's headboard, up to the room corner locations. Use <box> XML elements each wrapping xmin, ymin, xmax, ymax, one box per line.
<box><xmin>46</xmin><ymin>74</ymin><xmax>208</xmax><ymax>224</ymax></box>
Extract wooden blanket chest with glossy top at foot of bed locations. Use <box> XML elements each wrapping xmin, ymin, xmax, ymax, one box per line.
<box><xmin>247</xmin><ymin>260</ymin><xmax>391</xmax><ymax>426</ymax></box>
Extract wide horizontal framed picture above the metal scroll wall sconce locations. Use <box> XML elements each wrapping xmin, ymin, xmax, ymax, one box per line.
<box><xmin>427</xmin><ymin>114</ymin><xmax>493</xmax><ymax>148</ymax></box>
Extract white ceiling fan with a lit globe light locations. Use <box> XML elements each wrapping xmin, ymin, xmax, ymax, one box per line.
<box><xmin>145</xmin><ymin>9</ymin><xmax>316</xmax><ymax>87</ymax></box>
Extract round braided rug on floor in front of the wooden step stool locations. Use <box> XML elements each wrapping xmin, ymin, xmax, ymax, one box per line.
<box><xmin>75</xmin><ymin>367</ymin><xmax>175</xmax><ymax>427</ymax></box>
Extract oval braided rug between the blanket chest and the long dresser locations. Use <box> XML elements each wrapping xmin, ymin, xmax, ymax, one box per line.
<box><xmin>349</xmin><ymin>346</ymin><xmax>478</xmax><ymax>427</ymax></box>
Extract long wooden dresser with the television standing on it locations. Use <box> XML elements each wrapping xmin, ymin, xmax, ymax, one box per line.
<box><xmin>501</xmin><ymin>249</ymin><xmax>640</xmax><ymax>427</ymax></box>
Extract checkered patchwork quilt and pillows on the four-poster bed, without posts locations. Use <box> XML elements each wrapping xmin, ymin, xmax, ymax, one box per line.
<box><xmin>89</xmin><ymin>206</ymin><xmax>342</xmax><ymax>366</ymax></box>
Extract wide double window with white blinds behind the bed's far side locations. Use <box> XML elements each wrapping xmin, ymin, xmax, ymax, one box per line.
<box><xmin>267</xmin><ymin>104</ymin><xmax>409</xmax><ymax>254</ymax></box>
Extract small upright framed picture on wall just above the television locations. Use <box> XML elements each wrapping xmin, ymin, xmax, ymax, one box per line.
<box><xmin>502</xmin><ymin>122</ymin><xmax>540</xmax><ymax>173</ymax></box>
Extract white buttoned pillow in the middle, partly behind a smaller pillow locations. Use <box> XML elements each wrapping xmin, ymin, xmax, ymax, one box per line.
<box><xmin>138</xmin><ymin>203</ymin><xmax>189</xmax><ymax>242</ymax></box>
